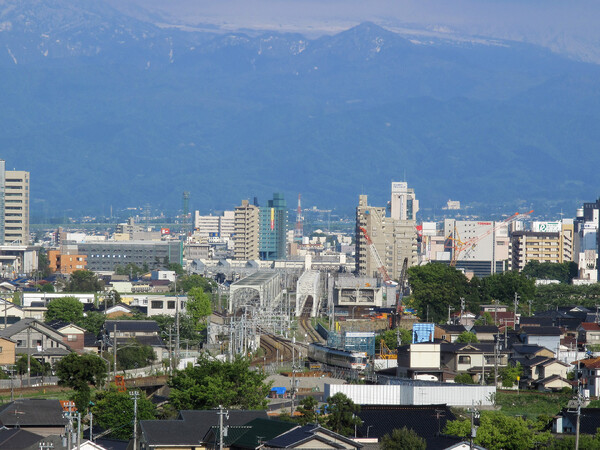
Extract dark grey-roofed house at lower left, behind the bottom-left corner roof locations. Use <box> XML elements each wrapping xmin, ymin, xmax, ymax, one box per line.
<box><xmin>0</xmin><ymin>398</ymin><xmax>67</xmax><ymax>436</ymax></box>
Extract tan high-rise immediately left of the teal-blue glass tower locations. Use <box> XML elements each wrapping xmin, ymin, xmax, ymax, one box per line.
<box><xmin>233</xmin><ymin>200</ymin><xmax>259</xmax><ymax>261</ymax></box>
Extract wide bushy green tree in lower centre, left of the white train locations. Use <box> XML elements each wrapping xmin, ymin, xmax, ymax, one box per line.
<box><xmin>169</xmin><ymin>356</ymin><xmax>271</xmax><ymax>410</ymax></box>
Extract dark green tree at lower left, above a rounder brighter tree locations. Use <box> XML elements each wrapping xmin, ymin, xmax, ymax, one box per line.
<box><xmin>56</xmin><ymin>353</ymin><xmax>107</xmax><ymax>411</ymax></box>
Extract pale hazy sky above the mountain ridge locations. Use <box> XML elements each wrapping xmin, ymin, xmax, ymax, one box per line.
<box><xmin>107</xmin><ymin>0</ymin><xmax>600</xmax><ymax>62</ymax></box>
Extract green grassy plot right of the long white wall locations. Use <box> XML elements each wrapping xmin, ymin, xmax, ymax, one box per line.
<box><xmin>496</xmin><ymin>391</ymin><xmax>573</xmax><ymax>419</ymax></box>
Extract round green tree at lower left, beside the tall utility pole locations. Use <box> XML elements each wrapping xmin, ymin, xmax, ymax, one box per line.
<box><xmin>92</xmin><ymin>386</ymin><xmax>156</xmax><ymax>439</ymax></box>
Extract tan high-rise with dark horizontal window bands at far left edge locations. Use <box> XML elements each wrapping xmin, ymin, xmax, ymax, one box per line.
<box><xmin>4</xmin><ymin>170</ymin><xmax>29</xmax><ymax>245</ymax></box>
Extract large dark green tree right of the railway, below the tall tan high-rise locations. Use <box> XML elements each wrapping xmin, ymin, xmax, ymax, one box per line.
<box><xmin>408</xmin><ymin>263</ymin><xmax>478</xmax><ymax>322</ymax></box>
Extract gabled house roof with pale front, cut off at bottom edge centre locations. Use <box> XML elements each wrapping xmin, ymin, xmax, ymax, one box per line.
<box><xmin>265</xmin><ymin>424</ymin><xmax>363</xmax><ymax>449</ymax></box>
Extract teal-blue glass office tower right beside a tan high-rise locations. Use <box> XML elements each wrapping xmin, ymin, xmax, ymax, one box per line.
<box><xmin>259</xmin><ymin>193</ymin><xmax>287</xmax><ymax>261</ymax></box>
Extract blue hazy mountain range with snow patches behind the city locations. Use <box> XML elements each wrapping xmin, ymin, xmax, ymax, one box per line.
<box><xmin>0</xmin><ymin>0</ymin><xmax>600</xmax><ymax>216</ymax></box>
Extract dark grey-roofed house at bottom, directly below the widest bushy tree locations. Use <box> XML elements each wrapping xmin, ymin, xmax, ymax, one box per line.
<box><xmin>139</xmin><ymin>410</ymin><xmax>268</xmax><ymax>450</ymax></box>
